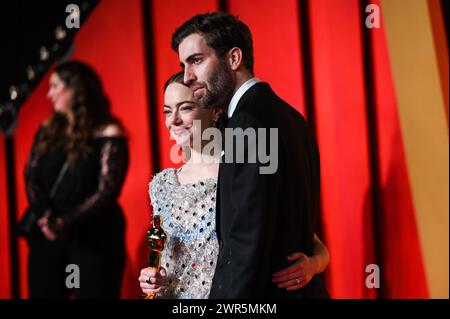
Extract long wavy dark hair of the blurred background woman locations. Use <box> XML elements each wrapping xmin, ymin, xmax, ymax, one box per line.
<box><xmin>37</xmin><ymin>61</ymin><xmax>123</xmax><ymax>165</ymax></box>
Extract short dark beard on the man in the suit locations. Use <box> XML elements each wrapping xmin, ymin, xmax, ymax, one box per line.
<box><xmin>199</xmin><ymin>60</ymin><xmax>235</xmax><ymax>110</ymax></box>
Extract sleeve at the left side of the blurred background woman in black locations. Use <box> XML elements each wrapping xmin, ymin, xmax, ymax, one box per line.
<box><xmin>24</xmin><ymin>129</ymin><xmax>50</xmax><ymax>216</ymax></box>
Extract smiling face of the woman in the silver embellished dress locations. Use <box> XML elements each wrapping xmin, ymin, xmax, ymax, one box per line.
<box><xmin>164</xmin><ymin>83</ymin><xmax>218</xmax><ymax>147</ymax></box>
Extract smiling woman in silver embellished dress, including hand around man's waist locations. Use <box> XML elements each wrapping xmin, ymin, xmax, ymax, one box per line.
<box><xmin>139</xmin><ymin>73</ymin><xmax>329</xmax><ymax>299</ymax></box>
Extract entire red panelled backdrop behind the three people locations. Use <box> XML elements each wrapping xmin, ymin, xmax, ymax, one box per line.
<box><xmin>0</xmin><ymin>0</ymin><xmax>448</xmax><ymax>298</ymax></box>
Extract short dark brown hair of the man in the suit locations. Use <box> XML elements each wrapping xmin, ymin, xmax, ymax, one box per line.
<box><xmin>172</xmin><ymin>12</ymin><xmax>254</xmax><ymax>75</ymax></box>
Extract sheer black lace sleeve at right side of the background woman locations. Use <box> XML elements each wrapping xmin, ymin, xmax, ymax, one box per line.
<box><xmin>70</xmin><ymin>138</ymin><xmax>128</xmax><ymax>224</ymax></box>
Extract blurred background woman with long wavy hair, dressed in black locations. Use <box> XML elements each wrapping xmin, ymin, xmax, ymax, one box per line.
<box><xmin>25</xmin><ymin>61</ymin><xmax>128</xmax><ymax>298</ymax></box>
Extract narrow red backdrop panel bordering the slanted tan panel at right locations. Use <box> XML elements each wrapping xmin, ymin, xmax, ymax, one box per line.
<box><xmin>369</xmin><ymin>2</ymin><xmax>428</xmax><ymax>298</ymax></box>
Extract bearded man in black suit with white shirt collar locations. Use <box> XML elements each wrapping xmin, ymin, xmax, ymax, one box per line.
<box><xmin>172</xmin><ymin>12</ymin><xmax>328</xmax><ymax>298</ymax></box>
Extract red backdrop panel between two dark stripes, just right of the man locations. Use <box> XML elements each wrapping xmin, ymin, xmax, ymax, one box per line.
<box><xmin>306</xmin><ymin>0</ymin><xmax>375</xmax><ymax>298</ymax></box>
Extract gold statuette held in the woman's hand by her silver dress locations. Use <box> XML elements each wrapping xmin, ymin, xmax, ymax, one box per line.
<box><xmin>144</xmin><ymin>215</ymin><xmax>167</xmax><ymax>299</ymax></box>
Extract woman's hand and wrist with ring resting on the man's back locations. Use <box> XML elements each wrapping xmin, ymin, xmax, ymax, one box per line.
<box><xmin>272</xmin><ymin>234</ymin><xmax>330</xmax><ymax>291</ymax></box>
